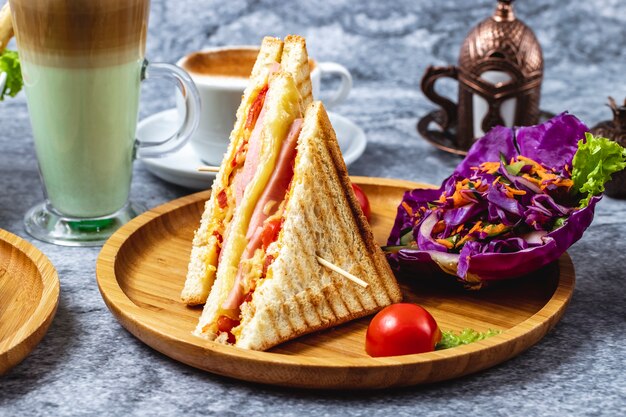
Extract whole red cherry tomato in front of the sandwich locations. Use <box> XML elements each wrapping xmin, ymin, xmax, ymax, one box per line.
<box><xmin>365</xmin><ymin>303</ymin><xmax>441</xmax><ymax>357</ymax></box>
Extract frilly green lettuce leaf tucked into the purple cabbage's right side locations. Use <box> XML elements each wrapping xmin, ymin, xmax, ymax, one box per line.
<box><xmin>572</xmin><ymin>132</ymin><xmax>626</xmax><ymax>208</ymax></box>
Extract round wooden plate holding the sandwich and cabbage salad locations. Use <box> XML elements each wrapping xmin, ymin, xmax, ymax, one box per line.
<box><xmin>96</xmin><ymin>177</ymin><xmax>574</xmax><ymax>389</ymax></box>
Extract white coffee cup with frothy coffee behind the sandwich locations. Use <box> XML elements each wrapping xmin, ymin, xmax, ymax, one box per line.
<box><xmin>176</xmin><ymin>45</ymin><xmax>352</xmax><ymax>165</ymax></box>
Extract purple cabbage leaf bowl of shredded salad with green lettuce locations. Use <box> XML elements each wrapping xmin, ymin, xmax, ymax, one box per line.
<box><xmin>383</xmin><ymin>113</ymin><xmax>626</xmax><ymax>289</ymax></box>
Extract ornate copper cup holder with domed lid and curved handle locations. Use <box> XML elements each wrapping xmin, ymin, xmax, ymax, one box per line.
<box><xmin>420</xmin><ymin>0</ymin><xmax>543</xmax><ymax>150</ymax></box>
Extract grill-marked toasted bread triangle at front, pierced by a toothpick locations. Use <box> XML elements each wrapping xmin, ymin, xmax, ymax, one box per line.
<box><xmin>202</xmin><ymin>102</ymin><xmax>402</xmax><ymax>350</ymax></box>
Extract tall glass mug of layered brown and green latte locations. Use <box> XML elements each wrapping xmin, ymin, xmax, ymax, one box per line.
<box><xmin>10</xmin><ymin>0</ymin><xmax>200</xmax><ymax>246</ymax></box>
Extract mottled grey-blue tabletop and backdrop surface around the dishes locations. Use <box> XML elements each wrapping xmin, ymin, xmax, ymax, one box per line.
<box><xmin>0</xmin><ymin>0</ymin><xmax>626</xmax><ymax>416</ymax></box>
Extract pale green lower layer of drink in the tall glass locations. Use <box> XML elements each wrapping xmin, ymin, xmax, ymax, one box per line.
<box><xmin>22</xmin><ymin>60</ymin><xmax>141</xmax><ymax>218</ymax></box>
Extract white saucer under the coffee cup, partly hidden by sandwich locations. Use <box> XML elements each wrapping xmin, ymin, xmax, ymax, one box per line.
<box><xmin>137</xmin><ymin>109</ymin><xmax>367</xmax><ymax>190</ymax></box>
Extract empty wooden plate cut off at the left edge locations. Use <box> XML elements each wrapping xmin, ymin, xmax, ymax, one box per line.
<box><xmin>0</xmin><ymin>229</ymin><xmax>59</xmax><ymax>375</ymax></box>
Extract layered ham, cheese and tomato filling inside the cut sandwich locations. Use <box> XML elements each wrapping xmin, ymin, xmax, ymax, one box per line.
<box><xmin>202</xmin><ymin>70</ymin><xmax>303</xmax><ymax>343</ymax></box>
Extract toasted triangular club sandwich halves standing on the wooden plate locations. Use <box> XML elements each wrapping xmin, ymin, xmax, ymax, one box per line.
<box><xmin>182</xmin><ymin>37</ymin><xmax>402</xmax><ymax>350</ymax></box>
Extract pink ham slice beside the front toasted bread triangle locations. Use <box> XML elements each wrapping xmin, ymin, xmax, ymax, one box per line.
<box><xmin>222</xmin><ymin>116</ymin><xmax>303</xmax><ymax>310</ymax></box>
